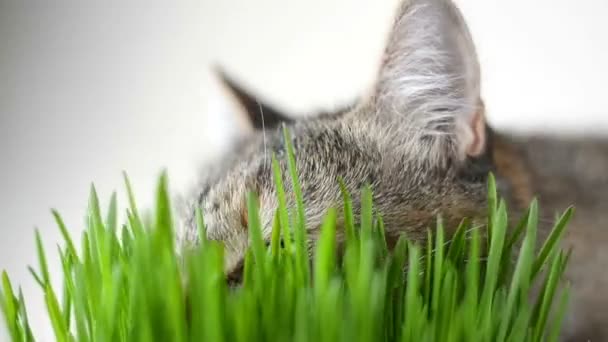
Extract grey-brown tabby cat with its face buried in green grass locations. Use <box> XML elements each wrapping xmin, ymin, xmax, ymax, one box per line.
<box><xmin>181</xmin><ymin>0</ymin><xmax>608</xmax><ymax>341</ymax></box>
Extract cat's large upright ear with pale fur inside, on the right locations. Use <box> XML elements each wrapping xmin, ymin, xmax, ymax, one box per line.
<box><xmin>372</xmin><ymin>0</ymin><xmax>486</xmax><ymax>159</ymax></box>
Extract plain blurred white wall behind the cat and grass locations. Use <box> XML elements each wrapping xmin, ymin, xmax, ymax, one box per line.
<box><xmin>0</xmin><ymin>0</ymin><xmax>608</xmax><ymax>341</ymax></box>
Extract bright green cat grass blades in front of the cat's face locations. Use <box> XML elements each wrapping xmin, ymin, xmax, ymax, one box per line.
<box><xmin>0</xmin><ymin>129</ymin><xmax>572</xmax><ymax>342</ymax></box>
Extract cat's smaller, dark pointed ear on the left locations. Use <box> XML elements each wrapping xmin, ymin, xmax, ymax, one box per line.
<box><xmin>213</xmin><ymin>66</ymin><xmax>293</xmax><ymax>130</ymax></box>
